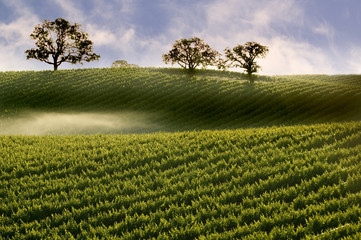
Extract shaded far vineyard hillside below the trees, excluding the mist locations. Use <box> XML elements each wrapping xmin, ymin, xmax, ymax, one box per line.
<box><xmin>0</xmin><ymin>68</ymin><xmax>361</xmax><ymax>133</ymax></box>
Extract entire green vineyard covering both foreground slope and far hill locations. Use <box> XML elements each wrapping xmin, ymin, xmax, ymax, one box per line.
<box><xmin>0</xmin><ymin>68</ymin><xmax>361</xmax><ymax>240</ymax></box>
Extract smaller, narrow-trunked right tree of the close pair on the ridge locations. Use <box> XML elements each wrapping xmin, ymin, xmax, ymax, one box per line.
<box><xmin>224</xmin><ymin>42</ymin><xmax>269</xmax><ymax>82</ymax></box>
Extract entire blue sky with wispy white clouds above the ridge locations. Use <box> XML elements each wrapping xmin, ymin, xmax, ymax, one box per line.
<box><xmin>0</xmin><ymin>0</ymin><xmax>361</xmax><ymax>75</ymax></box>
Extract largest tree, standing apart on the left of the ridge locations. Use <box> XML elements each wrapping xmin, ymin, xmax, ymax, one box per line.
<box><xmin>25</xmin><ymin>18</ymin><xmax>100</xmax><ymax>71</ymax></box>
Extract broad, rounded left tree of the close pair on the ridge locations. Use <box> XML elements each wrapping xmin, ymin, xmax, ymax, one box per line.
<box><xmin>162</xmin><ymin>37</ymin><xmax>220</xmax><ymax>71</ymax></box>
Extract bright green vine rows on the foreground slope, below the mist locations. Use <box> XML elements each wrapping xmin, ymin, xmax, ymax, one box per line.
<box><xmin>0</xmin><ymin>122</ymin><xmax>361</xmax><ymax>239</ymax></box>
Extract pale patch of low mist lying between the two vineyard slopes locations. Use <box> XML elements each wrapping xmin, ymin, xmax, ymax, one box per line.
<box><xmin>0</xmin><ymin>112</ymin><xmax>159</xmax><ymax>135</ymax></box>
